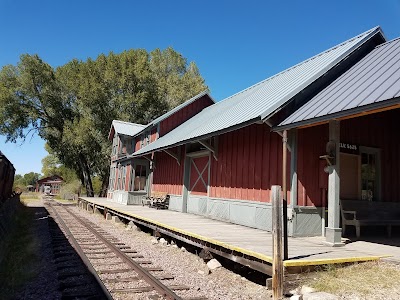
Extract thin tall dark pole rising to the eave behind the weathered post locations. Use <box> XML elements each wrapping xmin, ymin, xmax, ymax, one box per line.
<box><xmin>282</xmin><ymin>130</ymin><xmax>289</xmax><ymax>260</ymax></box>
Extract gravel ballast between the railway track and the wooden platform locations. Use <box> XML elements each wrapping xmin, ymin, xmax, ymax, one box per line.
<box><xmin>74</xmin><ymin>203</ymin><xmax>271</xmax><ymax>300</ymax></box>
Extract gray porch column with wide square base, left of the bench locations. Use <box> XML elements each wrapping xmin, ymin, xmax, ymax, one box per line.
<box><xmin>326</xmin><ymin>120</ymin><xmax>343</xmax><ymax>247</ymax></box>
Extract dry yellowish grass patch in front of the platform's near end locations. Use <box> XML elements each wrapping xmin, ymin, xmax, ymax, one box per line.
<box><xmin>303</xmin><ymin>261</ymin><xmax>400</xmax><ymax>299</ymax></box>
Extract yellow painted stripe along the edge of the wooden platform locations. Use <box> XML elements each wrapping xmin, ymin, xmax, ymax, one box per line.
<box><xmin>81</xmin><ymin>198</ymin><xmax>391</xmax><ymax>267</ymax></box>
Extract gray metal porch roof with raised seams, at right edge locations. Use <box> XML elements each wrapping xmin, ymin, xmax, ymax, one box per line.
<box><xmin>277</xmin><ymin>38</ymin><xmax>400</xmax><ymax>129</ymax></box>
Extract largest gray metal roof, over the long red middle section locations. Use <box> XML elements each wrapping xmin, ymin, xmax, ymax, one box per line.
<box><xmin>134</xmin><ymin>27</ymin><xmax>383</xmax><ymax>156</ymax></box>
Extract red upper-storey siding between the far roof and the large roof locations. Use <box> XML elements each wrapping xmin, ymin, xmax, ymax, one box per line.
<box><xmin>160</xmin><ymin>96</ymin><xmax>213</xmax><ymax>137</ymax></box>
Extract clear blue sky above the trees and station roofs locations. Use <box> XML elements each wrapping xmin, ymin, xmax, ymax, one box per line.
<box><xmin>0</xmin><ymin>0</ymin><xmax>400</xmax><ymax>174</ymax></box>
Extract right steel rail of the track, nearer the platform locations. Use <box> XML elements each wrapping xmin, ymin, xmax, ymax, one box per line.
<box><xmin>64</xmin><ymin>207</ymin><xmax>182</xmax><ymax>300</ymax></box>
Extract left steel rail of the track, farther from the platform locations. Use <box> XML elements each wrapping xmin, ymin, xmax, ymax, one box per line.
<box><xmin>49</xmin><ymin>204</ymin><xmax>114</xmax><ymax>300</ymax></box>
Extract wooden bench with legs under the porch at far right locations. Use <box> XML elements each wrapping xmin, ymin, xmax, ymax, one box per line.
<box><xmin>340</xmin><ymin>200</ymin><xmax>400</xmax><ymax>238</ymax></box>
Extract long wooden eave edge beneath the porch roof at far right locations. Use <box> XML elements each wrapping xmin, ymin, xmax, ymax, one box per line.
<box><xmin>272</xmin><ymin>97</ymin><xmax>400</xmax><ymax>132</ymax></box>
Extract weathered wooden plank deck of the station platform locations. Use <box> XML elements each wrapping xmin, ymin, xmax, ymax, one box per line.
<box><xmin>81</xmin><ymin>197</ymin><xmax>400</xmax><ymax>266</ymax></box>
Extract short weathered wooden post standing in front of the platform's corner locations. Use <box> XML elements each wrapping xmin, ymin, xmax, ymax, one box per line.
<box><xmin>271</xmin><ymin>185</ymin><xmax>284</xmax><ymax>300</ymax></box>
